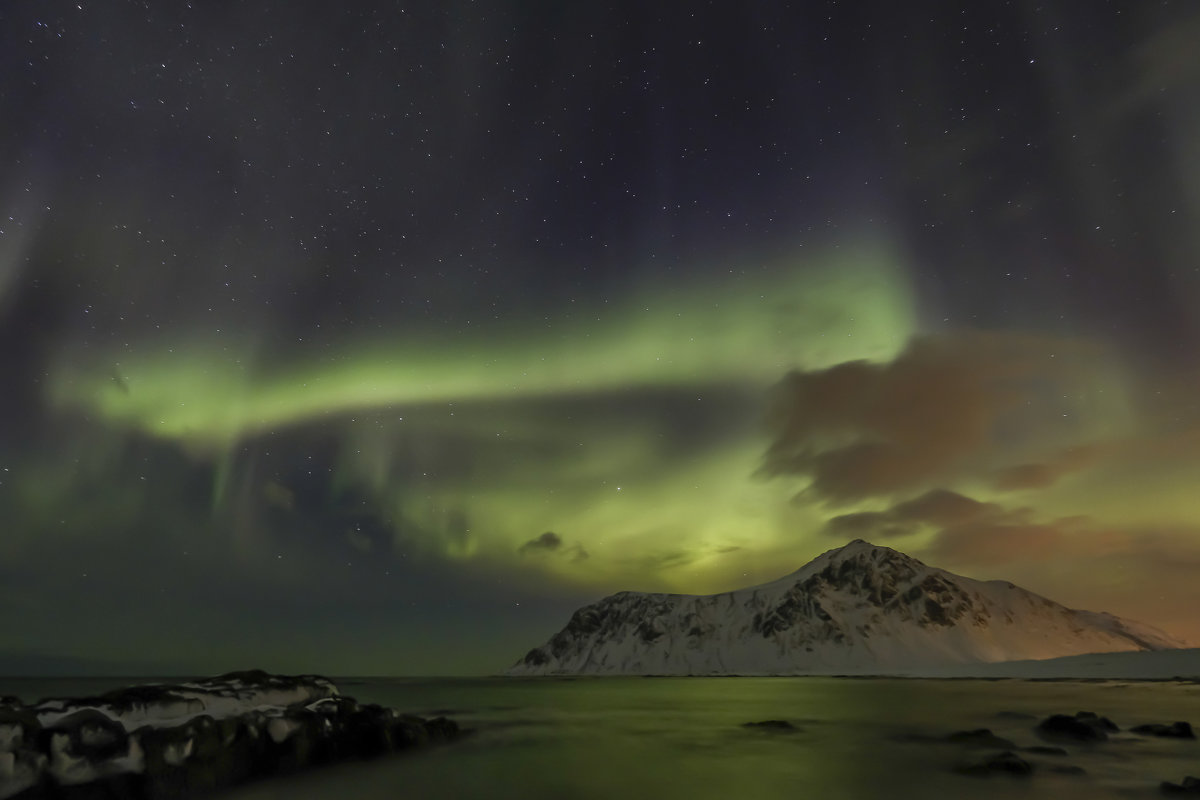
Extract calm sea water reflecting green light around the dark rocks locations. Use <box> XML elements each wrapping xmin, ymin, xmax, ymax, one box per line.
<box><xmin>0</xmin><ymin>678</ymin><xmax>1200</xmax><ymax>800</ymax></box>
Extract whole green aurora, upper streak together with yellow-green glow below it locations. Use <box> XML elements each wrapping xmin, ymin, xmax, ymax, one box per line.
<box><xmin>39</xmin><ymin>246</ymin><xmax>917</xmax><ymax>590</ymax></box>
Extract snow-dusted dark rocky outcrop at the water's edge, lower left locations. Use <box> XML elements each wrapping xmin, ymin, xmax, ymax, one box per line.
<box><xmin>0</xmin><ymin>670</ymin><xmax>461</xmax><ymax>800</ymax></box>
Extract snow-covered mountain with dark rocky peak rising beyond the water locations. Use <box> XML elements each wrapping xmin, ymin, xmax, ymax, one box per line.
<box><xmin>508</xmin><ymin>540</ymin><xmax>1187</xmax><ymax>675</ymax></box>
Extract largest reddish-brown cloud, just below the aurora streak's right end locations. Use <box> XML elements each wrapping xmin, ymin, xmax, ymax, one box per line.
<box><xmin>762</xmin><ymin>333</ymin><xmax>1092</xmax><ymax>504</ymax></box>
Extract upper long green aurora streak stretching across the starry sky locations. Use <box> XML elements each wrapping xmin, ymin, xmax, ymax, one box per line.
<box><xmin>50</xmin><ymin>247</ymin><xmax>916</xmax><ymax>447</ymax></box>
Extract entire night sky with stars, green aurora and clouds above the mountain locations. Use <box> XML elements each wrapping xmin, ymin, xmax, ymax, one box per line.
<box><xmin>0</xmin><ymin>0</ymin><xmax>1200</xmax><ymax>674</ymax></box>
